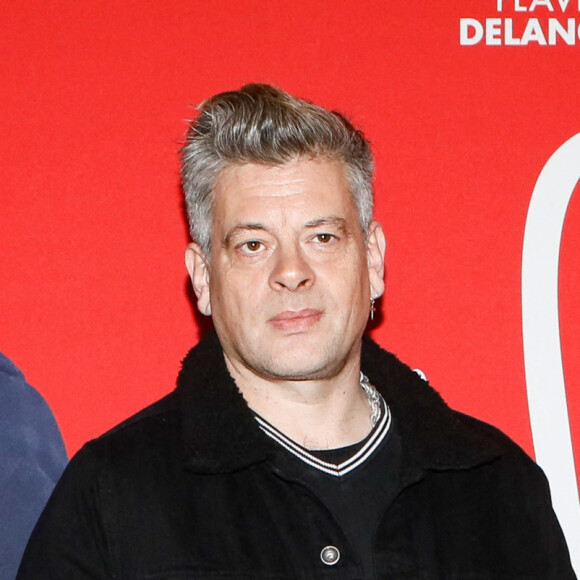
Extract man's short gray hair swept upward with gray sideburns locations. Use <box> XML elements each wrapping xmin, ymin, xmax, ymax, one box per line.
<box><xmin>181</xmin><ymin>84</ymin><xmax>373</xmax><ymax>255</ymax></box>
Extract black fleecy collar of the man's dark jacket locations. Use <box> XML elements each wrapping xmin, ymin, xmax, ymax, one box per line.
<box><xmin>176</xmin><ymin>331</ymin><xmax>501</xmax><ymax>473</ymax></box>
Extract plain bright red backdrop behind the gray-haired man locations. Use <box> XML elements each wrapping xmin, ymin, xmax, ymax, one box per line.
<box><xmin>0</xmin><ymin>0</ymin><xmax>580</xmax><ymax>564</ymax></box>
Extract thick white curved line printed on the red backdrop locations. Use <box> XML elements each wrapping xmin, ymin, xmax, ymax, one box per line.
<box><xmin>522</xmin><ymin>133</ymin><xmax>580</xmax><ymax>573</ymax></box>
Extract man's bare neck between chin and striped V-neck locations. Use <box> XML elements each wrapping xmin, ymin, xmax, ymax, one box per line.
<box><xmin>226</xmin><ymin>357</ymin><xmax>371</xmax><ymax>449</ymax></box>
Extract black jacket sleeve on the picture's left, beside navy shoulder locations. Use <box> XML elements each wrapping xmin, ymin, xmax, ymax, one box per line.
<box><xmin>17</xmin><ymin>444</ymin><xmax>115</xmax><ymax>580</ymax></box>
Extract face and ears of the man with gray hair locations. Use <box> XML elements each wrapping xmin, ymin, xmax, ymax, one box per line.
<box><xmin>187</xmin><ymin>160</ymin><xmax>384</xmax><ymax>380</ymax></box>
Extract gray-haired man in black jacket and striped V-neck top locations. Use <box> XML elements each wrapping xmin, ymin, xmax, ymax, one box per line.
<box><xmin>19</xmin><ymin>85</ymin><xmax>574</xmax><ymax>580</ymax></box>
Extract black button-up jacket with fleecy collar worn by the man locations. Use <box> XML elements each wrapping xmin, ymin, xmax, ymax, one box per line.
<box><xmin>18</xmin><ymin>334</ymin><xmax>575</xmax><ymax>580</ymax></box>
